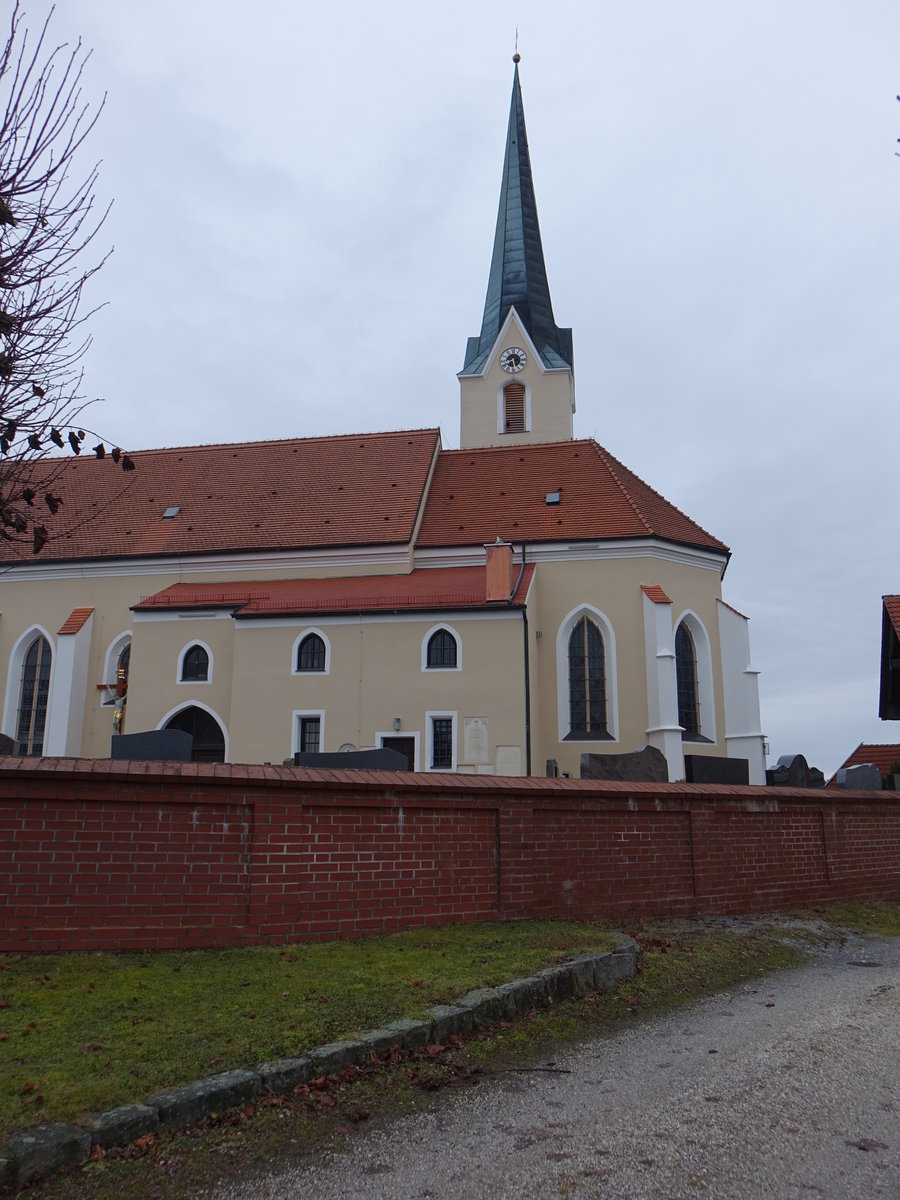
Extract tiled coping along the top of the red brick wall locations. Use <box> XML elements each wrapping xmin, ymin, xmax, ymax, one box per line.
<box><xmin>0</xmin><ymin>756</ymin><xmax>900</xmax><ymax>808</ymax></box>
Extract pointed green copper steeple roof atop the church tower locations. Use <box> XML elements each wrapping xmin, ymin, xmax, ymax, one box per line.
<box><xmin>461</xmin><ymin>63</ymin><xmax>572</xmax><ymax>376</ymax></box>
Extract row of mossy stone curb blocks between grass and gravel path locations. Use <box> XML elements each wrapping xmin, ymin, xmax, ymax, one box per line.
<box><xmin>0</xmin><ymin>934</ymin><xmax>641</xmax><ymax>1189</ymax></box>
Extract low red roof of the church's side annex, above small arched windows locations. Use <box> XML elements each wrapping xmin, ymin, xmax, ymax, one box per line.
<box><xmin>134</xmin><ymin>563</ymin><xmax>534</xmax><ymax>617</ymax></box>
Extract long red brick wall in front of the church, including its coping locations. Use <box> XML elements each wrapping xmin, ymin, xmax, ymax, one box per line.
<box><xmin>0</xmin><ymin>758</ymin><xmax>900</xmax><ymax>950</ymax></box>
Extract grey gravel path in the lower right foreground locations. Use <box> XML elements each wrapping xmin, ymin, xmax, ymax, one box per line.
<box><xmin>217</xmin><ymin>938</ymin><xmax>900</xmax><ymax>1200</ymax></box>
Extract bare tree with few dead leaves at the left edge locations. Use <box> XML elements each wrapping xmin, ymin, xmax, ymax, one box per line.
<box><xmin>0</xmin><ymin>0</ymin><xmax>133</xmax><ymax>554</ymax></box>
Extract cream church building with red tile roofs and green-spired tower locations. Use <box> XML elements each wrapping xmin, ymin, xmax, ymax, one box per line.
<box><xmin>0</xmin><ymin>65</ymin><xmax>764</xmax><ymax>784</ymax></box>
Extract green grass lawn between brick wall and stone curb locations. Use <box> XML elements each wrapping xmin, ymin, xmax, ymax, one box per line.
<box><xmin>0</xmin><ymin>920</ymin><xmax>613</xmax><ymax>1136</ymax></box>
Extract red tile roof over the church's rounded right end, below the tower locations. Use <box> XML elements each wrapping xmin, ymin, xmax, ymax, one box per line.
<box><xmin>419</xmin><ymin>440</ymin><xmax>727</xmax><ymax>553</ymax></box>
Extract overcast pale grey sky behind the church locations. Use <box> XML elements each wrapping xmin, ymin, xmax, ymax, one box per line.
<box><xmin>33</xmin><ymin>0</ymin><xmax>900</xmax><ymax>773</ymax></box>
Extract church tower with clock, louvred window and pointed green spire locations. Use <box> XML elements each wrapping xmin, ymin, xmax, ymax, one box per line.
<box><xmin>457</xmin><ymin>54</ymin><xmax>575</xmax><ymax>450</ymax></box>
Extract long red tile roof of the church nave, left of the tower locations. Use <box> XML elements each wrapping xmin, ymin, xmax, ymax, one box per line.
<box><xmin>0</xmin><ymin>430</ymin><xmax>440</xmax><ymax>563</ymax></box>
